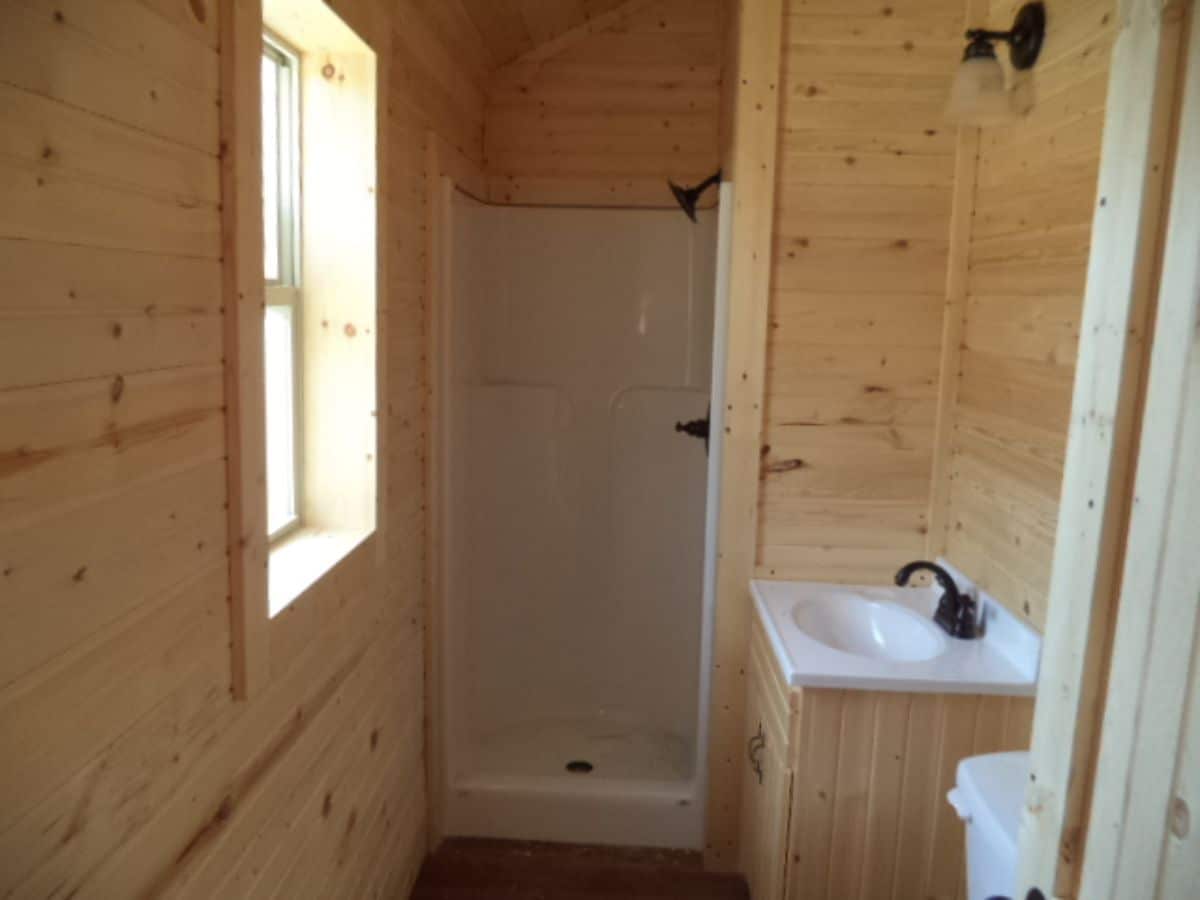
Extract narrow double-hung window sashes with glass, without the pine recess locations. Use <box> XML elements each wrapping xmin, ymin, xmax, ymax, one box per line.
<box><xmin>263</xmin><ymin>35</ymin><xmax>302</xmax><ymax>541</ymax></box>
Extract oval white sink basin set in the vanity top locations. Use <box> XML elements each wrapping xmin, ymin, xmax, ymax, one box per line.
<box><xmin>792</xmin><ymin>592</ymin><xmax>946</xmax><ymax>662</ymax></box>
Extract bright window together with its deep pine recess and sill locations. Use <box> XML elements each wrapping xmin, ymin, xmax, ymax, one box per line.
<box><xmin>254</xmin><ymin>0</ymin><xmax>379</xmax><ymax>618</ymax></box>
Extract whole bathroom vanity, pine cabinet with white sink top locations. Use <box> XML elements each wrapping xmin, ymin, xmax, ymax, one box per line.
<box><xmin>742</xmin><ymin>581</ymin><xmax>1040</xmax><ymax>900</ymax></box>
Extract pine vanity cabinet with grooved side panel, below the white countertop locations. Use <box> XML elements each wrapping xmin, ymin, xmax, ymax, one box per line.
<box><xmin>740</xmin><ymin>620</ymin><xmax>1033</xmax><ymax>900</ymax></box>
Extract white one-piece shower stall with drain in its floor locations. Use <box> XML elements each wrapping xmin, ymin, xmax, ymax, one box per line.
<box><xmin>443</xmin><ymin>194</ymin><xmax>715</xmax><ymax>846</ymax></box>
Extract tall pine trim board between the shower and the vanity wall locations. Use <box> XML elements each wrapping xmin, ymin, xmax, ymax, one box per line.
<box><xmin>704</xmin><ymin>0</ymin><xmax>782</xmax><ymax>870</ymax></box>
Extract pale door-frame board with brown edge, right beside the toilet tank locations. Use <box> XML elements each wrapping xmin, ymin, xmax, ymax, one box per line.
<box><xmin>1018</xmin><ymin>1</ymin><xmax>1180</xmax><ymax>896</ymax></box>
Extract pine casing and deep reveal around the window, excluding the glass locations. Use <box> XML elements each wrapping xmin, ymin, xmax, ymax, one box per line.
<box><xmin>217</xmin><ymin>0</ymin><xmax>376</xmax><ymax>703</ymax></box>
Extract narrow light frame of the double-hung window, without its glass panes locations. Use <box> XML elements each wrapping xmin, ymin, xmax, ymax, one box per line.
<box><xmin>262</xmin><ymin>28</ymin><xmax>304</xmax><ymax>546</ymax></box>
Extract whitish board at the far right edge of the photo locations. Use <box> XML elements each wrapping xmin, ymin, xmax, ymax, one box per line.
<box><xmin>1080</xmin><ymin>7</ymin><xmax>1200</xmax><ymax>900</ymax></box>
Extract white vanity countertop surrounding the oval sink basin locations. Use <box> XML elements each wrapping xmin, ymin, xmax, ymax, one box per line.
<box><xmin>750</xmin><ymin>573</ymin><xmax>1042</xmax><ymax>696</ymax></box>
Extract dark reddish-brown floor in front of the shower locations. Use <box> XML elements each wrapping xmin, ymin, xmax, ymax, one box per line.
<box><xmin>413</xmin><ymin>838</ymin><xmax>750</xmax><ymax>900</ymax></box>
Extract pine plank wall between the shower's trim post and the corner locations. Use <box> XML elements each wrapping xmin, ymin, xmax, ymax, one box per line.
<box><xmin>756</xmin><ymin>0</ymin><xmax>970</xmax><ymax>582</ymax></box>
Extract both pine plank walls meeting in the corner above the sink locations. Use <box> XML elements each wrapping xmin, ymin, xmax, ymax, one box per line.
<box><xmin>757</xmin><ymin>0</ymin><xmax>1115</xmax><ymax>629</ymax></box>
